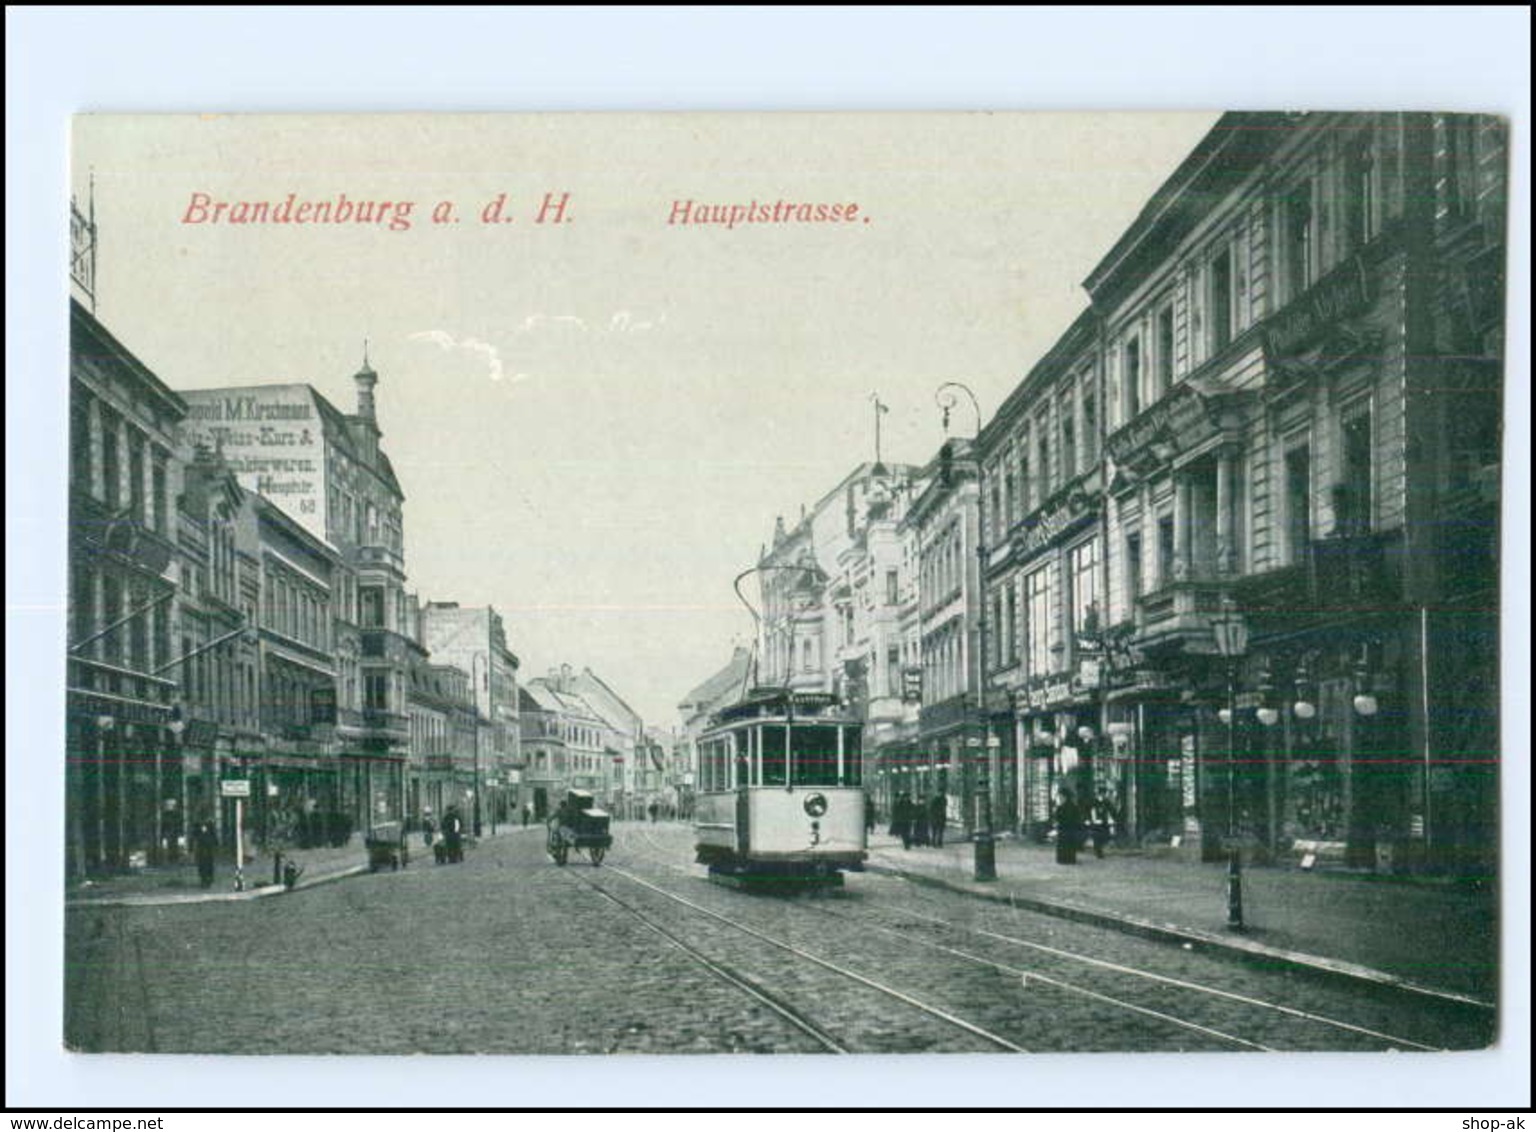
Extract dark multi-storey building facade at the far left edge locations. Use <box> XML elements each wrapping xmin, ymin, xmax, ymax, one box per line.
<box><xmin>66</xmin><ymin>298</ymin><xmax>187</xmax><ymax>877</ymax></box>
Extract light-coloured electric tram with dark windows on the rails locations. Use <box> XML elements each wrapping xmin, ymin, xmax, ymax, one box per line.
<box><xmin>694</xmin><ymin>688</ymin><xmax>865</xmax><ymax>883</ymax></box>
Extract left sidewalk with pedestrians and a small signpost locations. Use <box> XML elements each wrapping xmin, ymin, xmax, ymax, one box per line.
<box><xmin>66</xmin><ymin>825</ymin><xmax>534</xmax><ymax>906</ymax></box>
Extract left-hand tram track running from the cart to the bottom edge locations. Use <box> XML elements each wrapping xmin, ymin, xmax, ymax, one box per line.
<box><xmin>568</xmin><ymin>866</ymin><xmax>1029</xmax><ymax>1054</ymax></box>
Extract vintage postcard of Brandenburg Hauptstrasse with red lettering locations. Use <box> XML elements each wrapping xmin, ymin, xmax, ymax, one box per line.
<box><xmin>61</xmin><ymin>111</ymin><xmax>1510</xmax><ymax>1055</ymax></box>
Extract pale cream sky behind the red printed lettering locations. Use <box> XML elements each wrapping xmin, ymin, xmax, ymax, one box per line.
<box><xmin>71</xmin><ymin>112</ymin><xmax>1217</xmax><ymax>727</ymax></box>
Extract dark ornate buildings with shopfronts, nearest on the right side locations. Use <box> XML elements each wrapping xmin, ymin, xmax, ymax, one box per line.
<box><xmin>958</xmin><ymin>114</ymin><xmax>1507</xmax><ymax>869</ymax></box>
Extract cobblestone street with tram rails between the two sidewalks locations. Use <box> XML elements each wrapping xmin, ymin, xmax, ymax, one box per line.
<box><xmin>66</xmin><ymin>823</ymin><xmax>1491</xmax><ymax>1054</ymax></box>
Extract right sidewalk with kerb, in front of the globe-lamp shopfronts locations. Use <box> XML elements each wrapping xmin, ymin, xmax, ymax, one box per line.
<box><xmin>869</xmin><ymin>832</ymin><xmax>1499</xmax><ymax>1003</ymax></box>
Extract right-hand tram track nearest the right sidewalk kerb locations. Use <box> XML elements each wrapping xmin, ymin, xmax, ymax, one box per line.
<box><xmin>617</xmin><ymin>831</ymin><xmax>1480</xmax><ymax>1051</ymax></box>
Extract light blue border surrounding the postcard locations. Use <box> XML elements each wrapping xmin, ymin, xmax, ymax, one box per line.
<box><xmin>6</xmin><ymin>8</ymin><xmax>1530</xmax><ymax>1105</ymax></box>
